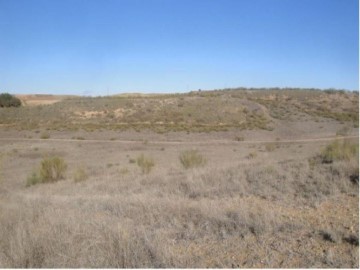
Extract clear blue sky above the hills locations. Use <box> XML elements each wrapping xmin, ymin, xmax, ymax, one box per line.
<box><xmin>0</xmin><ymin>0</ymin><xmax>359</xmax><ymax>95</ymax></box>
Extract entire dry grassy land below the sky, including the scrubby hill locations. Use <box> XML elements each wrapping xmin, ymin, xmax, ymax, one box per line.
<box><xmin>0</xmin><ymin>89</ymin><xmax>359</xmax><ymax>268</ymax></box>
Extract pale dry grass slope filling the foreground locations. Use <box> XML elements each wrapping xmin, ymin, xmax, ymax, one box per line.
<box><xmin>0</xmin><ymin>146</ymin><xmax>358</xmax><ymax>268</ymax></box>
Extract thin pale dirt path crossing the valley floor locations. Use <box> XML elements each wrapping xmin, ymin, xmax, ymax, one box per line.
<box><xmin>0</xmin><ymin>136</ymin><xmax>359</xmax><ymax>145</ymax></box>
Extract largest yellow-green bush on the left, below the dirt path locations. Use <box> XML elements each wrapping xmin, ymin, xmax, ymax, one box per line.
<box><xmin>40</xmin><ymin>157</ymin><xmax>67</xmax><ymax>183</ymax></box>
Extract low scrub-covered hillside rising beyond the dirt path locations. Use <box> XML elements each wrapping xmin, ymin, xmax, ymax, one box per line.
<box><xmin>0</xmin><ymin>88</ymin><xmax>359</xmax><ymax>131</ymax></box>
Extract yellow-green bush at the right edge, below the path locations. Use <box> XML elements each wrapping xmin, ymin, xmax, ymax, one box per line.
<box><xmin>320</xmin><ymin>140</ymin><xmax>359</xmax><ymax>163</ymax></box>
